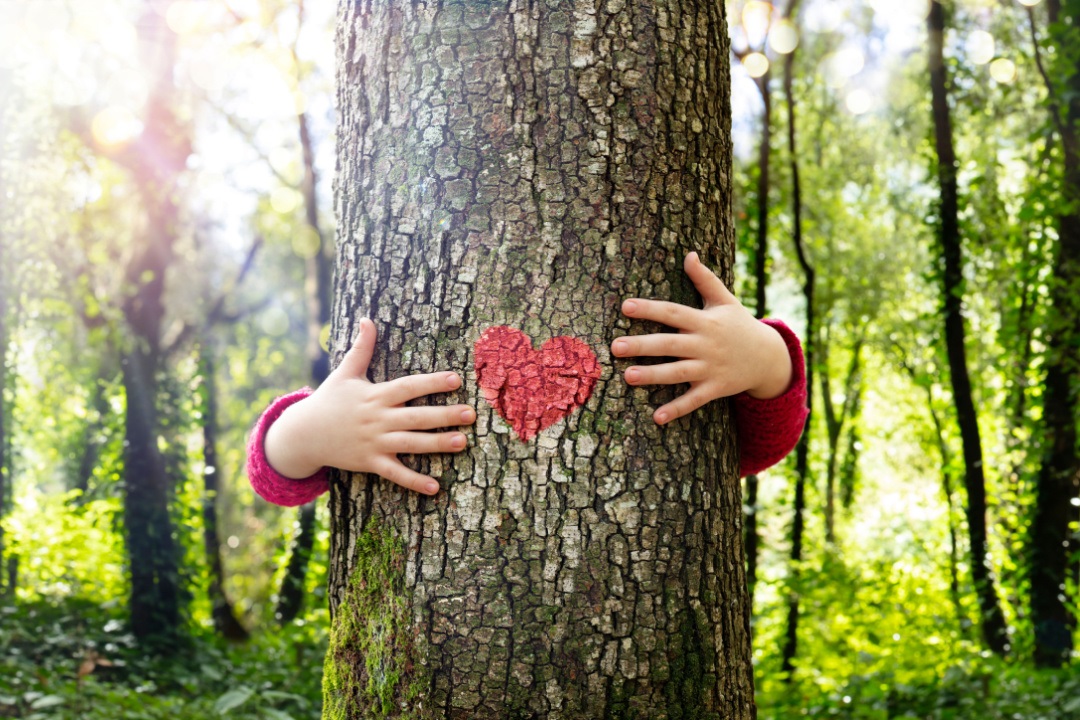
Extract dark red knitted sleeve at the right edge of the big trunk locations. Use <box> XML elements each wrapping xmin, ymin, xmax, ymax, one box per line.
<box><xmin>733</xmin><ymin>320</ymin><xmax>810</xmax><ymax>477</ymax></box>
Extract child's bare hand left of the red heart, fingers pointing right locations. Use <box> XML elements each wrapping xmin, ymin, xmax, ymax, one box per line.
<box><xmin>265</xmin><ymin>317</ymin><xmax>476</xmax><ymax>494</ymax></box>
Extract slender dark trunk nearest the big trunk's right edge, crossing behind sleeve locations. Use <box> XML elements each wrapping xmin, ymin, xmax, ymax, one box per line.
<box><xmin>745</xmin><ymin>67</ymin><xmax>772</xmax><ymax>612</ymax></box>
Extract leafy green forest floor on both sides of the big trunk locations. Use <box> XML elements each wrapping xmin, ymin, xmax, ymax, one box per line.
<box><xmin>0</xmin><ymin>599</ymin><xmax>1080</xmax><ymax>720</ymax></box>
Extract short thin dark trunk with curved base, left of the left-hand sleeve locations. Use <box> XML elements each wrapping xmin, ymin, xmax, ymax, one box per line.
<box><xmin>199</xmin><ymin>345</ymin><xmax>248</xmax><ymax>640</ymax></box>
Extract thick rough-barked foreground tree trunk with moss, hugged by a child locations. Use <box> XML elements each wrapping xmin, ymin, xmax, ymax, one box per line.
<box><xmin>324</xmin><ymin>0</ymin><xmax>754</xmax><ymax>720</ymax></box>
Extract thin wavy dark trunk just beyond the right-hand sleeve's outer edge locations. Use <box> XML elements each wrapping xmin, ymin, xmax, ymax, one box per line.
<box><xmin>781</xmin><ymin>0</ymin><xmax>816</xmax><ymax>682</ymax></box>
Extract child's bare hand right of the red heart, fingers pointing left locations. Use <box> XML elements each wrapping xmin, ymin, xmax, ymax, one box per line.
<box><xmin>611</xmin><ymin>253</ymin><xmax>792</xmax><ymax>425</ymax></box>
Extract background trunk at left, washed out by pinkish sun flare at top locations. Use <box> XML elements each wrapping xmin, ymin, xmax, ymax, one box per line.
<box><xmin>119</xmin><ymin>0</ymin><xmax>190</xmax><ymax>639</ymax></box>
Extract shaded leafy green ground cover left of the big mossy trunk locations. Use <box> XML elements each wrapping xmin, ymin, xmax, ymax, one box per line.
<box><xmin>0</xmin><ymin>597</ymin><xmax>325</xmax><ymax>720</ymax></box>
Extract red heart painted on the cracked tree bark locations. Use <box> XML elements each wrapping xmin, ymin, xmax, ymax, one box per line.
<box><xmin>475</xmin><ymin>325</ymin><xmax>600</xmax><ymax>440</ymax></box>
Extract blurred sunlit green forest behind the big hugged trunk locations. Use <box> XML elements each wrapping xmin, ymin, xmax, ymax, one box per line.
<box><xmin>0</xmin><ymin>0</ymin><xmax>1080</xmax><ymax>720</ymax></box>
